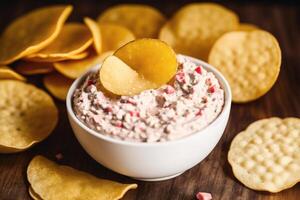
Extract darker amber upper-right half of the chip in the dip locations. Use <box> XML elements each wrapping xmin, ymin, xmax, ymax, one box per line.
<box><xmin>114</xmin><ymin>39</ymin><xmax>177</xmax><ymax>86</ymax></box>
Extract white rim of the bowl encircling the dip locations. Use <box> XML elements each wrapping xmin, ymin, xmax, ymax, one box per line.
<box><xmin>66</xmin><ymin>54</ymin><xmax>232</xmax><ymax>147</ymax></box>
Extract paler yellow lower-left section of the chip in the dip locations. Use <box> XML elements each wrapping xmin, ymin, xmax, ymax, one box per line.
<box><xmin>100</xmin><ymin>56</ymin><xmax>158</xmax><ymax>96</ymax></box>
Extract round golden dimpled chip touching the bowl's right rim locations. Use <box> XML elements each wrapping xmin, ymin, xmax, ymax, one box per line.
<box><xmin>208</xmin><ymin>30</ymin><xmax>281</xmax><ymax>103</ymax></box>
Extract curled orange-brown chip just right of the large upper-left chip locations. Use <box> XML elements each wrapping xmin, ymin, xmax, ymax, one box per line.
<box><xmin>27</xmin><ymin>22</ymin><xmax>93</xmax><ymax>59</ymax></box>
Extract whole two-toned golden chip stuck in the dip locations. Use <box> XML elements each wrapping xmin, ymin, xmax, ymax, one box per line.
<box><xmin>99</xmin><ymin>39</ymin><xmax>178</xmax><ymax>95</ymax></box>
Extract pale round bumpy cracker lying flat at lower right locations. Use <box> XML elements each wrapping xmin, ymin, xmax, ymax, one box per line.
<box><xmin>228</xmin><ymin>117</ymin><xmax>300</xmax><ymax>192</ymax></box>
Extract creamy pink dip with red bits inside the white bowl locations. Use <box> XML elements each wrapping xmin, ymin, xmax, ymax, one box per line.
<box><xmin>73</xmin><ymin>56</ymin><xmax>224</xmax><ymax>142</ymax></box>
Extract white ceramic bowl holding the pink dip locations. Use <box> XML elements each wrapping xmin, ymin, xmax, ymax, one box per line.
<box><xmin>66</xmin><ymin>56</ymin><xmax>231</xmax><ymax>181</ymax></box>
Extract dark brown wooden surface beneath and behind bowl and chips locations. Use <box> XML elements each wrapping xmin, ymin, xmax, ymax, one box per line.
<box><xmin>0</xmin><ymin>0</ymin><xmax>300</xmax><ymax>200</ymax></box>
